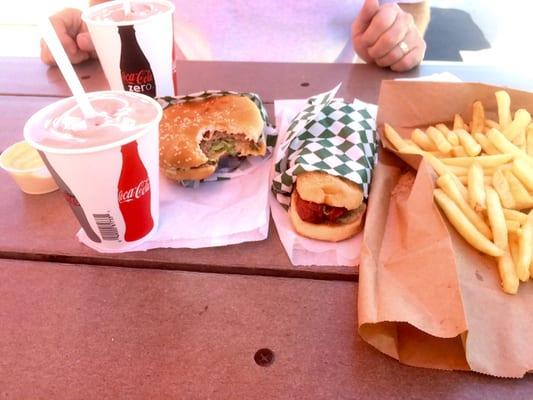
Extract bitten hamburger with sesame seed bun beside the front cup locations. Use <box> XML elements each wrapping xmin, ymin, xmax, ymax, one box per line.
<box><xmin>159</xmin><ymin>95</ymin><xmax>266</xmax><ymax>180</ymax></box>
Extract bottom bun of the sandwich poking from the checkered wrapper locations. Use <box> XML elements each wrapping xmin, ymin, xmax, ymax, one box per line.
<box><xmin>289</xmin><ymin>191</ymin><xmax>366</xmax><ymax>242</ymax></box>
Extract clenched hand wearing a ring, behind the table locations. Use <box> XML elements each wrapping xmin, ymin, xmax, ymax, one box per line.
<box><xmin>352</xmin><ymin>0</ymin><xmax>426</xmax><ymax>71</ymax></box>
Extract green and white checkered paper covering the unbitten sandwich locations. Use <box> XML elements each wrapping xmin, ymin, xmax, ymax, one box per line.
<box><xmin>272</xmin><ymin>84</ymin><xmax>378</xmax><ymax>206</ymax></box>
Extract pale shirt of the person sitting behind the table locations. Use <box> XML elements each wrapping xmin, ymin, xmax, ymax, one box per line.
<box><xmin>173</xmin><ymin>0</ymin><xmax>420</xmax><ymax>62</ymax></box>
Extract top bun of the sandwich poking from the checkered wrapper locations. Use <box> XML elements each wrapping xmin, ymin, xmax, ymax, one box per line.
<box><xmin>296</xmin><ymin>171</ymin><xmax>363</xmax><ymax>210</ymax></box>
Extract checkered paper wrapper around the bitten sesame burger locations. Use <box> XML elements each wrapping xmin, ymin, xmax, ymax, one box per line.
<box><xmin>157</xmin><ymin>90</ymin><xmax>277</xmax><ymax>187</ymax></box>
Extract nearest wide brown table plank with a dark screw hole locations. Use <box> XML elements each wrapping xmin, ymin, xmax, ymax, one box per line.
<box><xmin>0</xmin><ymin>260</ymin><xmax>533</xmax><ymax>399</ymax></box>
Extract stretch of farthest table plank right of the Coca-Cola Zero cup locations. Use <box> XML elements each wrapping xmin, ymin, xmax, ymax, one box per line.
<box><xmin>177</xmin><ymin>61</ymin><xmax>533</xmax><ymax>103</ymax></box>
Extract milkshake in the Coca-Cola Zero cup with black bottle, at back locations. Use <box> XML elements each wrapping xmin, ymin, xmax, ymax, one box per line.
<box><xmin>82</xmin><ymin>0</ymin><xmax>177</xmax><ymax>97</ymax></box>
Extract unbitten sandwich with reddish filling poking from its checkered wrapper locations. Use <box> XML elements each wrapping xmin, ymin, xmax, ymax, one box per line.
<box><xmin>289</xmin><ymin>172</ymin><xmax>366</xmax><ymax>242</ymax></box>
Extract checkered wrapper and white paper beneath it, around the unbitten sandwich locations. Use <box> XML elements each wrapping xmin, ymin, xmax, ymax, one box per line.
<box><xmin>270</xmin><ymin>85</ymin><xmax>378</xmax><ymax>265</ymax></box>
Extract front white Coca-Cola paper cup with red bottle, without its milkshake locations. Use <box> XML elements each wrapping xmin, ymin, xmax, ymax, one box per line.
<box><xmin>24</xmin><ymin>91</ymin><xmax>162</xmax><ymax>251</ymax></box>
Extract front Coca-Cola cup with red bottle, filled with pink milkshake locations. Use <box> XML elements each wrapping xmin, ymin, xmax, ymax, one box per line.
<box><xmin>24</xmin><ymin>91</ymin><xmax>162</xmax><ymax>252</ymax></box>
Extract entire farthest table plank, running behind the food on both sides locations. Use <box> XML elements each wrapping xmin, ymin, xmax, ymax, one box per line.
<box><xmin>0</xmin><ymin>57</ymin><xmax>533</xmax><ymax>102</ymax></box>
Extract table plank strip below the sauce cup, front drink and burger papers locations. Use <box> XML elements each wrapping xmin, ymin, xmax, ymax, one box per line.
<box><xmin>0</xmin><ymin>173</ymin><xmax>356</xmax><ymax>280</ymax></box>
